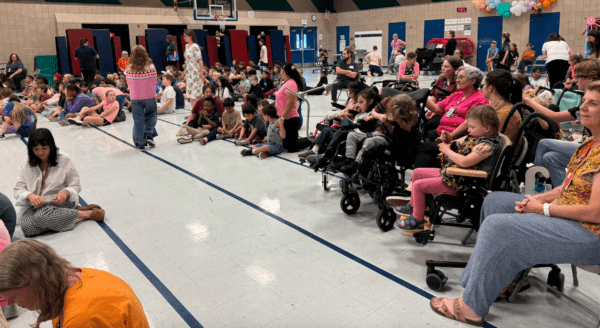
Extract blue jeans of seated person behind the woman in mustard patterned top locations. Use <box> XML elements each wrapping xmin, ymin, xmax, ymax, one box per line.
<box><xmin>534</xmin><ymin>139</ymin><xmax>579</xmax><ymax>187</ymax></box>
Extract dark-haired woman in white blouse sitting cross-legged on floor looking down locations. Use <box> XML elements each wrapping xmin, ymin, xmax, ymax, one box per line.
<box><xmin>14</xmin><ymin>129</ymin><xmax>104</xmax><ymax>237</ymax></box>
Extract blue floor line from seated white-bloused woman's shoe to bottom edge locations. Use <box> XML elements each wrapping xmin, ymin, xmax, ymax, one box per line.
<box><xmin>21</xmin><ymin>138</ymin><xmax>202</xmax><ymax>328</ymax></box>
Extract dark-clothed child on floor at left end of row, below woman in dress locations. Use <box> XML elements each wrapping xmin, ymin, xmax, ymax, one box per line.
<box><xmin>177</xmin><ymin>97</ymin><xmax>219</xmax><ymax>146</ymax></box>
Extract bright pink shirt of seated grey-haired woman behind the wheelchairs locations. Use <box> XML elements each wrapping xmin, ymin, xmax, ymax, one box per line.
<box><xmin>437</xmin><ymin>90</ymin><xmax>490</xmax><ymax>135</ymax></box>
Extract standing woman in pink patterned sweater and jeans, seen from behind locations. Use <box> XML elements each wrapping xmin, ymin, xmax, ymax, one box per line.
<box><xmin>125</xmin><ymin>45</ymin><xmax>158</xmax><ymax>151</ymax></box>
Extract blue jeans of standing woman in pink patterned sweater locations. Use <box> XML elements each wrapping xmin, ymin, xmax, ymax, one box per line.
<box><xmin>131</xmin><ymin>98</ymin><xmax>158</xmax><ymax>148</ymax></box>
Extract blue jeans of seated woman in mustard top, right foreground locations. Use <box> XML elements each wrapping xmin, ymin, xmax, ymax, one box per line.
<box><xmin>460</xmin><ymin>192</ymin><xmax>600</xmax><ymax>317</ymax></box>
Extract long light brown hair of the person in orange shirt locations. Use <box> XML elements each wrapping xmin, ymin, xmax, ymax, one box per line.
<box><xmin>0</xmin><ymin>239</ymin><xmax>74</xmax><ymax>327</ymax></box>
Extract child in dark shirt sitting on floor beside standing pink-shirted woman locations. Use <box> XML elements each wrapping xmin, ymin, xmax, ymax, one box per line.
<box><xmin>242</xmin><ymin>104</ymin><xmax>285</xmax><ymax>159</ymax></box>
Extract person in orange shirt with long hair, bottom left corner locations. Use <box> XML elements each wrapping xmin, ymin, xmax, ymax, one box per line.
<box><xmin>0</xmin><ymin>239</ymin><xmax>148</xmax><ymax>328</ymax></box>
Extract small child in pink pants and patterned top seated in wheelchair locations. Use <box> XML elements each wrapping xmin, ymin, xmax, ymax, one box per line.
<box><xmin>388</xmin><ymin>105</ymin><xmax>502</xmax><ymax>231</ymax></box>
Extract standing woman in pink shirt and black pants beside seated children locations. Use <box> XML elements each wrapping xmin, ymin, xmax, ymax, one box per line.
<box><xmin>275</xmin><ymin>63</ymin><xmax>302</xmax><ymax>153</ymax></box>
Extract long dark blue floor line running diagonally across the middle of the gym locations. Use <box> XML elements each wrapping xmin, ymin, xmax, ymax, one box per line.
<box><xmin>86</xmin><ymin>126</ymin><xmax>494</xmax><ymax>328</ymax></box>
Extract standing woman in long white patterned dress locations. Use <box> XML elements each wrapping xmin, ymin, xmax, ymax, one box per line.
<box><xmin>183</xmin><ymin>30</ymin><xmax>204</xmax><ymax>108</ymax></box>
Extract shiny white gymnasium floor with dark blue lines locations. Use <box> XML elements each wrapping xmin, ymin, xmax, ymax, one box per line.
<box><xmin>0</xmin><ymin>69</ymin><xmax>600</xmax><ymax>328</ymax></box>
